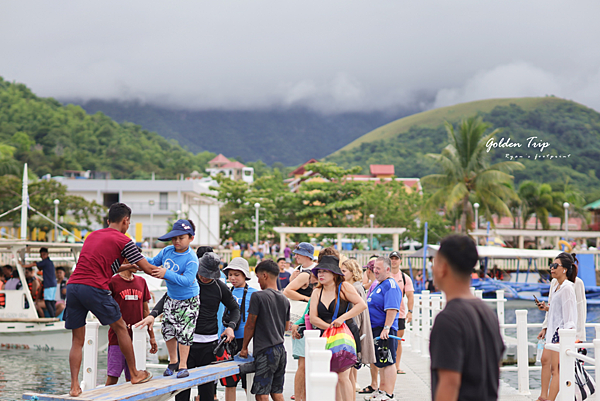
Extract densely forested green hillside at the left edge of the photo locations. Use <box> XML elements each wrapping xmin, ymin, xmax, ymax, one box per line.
<box><xmin>0</xmin><ymin>77</ymin><xmax>215</xmax><ymax>179</ymax></box>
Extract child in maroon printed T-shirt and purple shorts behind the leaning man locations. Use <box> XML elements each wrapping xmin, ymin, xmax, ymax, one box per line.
<box><xmin>106</xmin><ymin>267</ymin><xmax>158</xmax><ymax>386</ymax></box>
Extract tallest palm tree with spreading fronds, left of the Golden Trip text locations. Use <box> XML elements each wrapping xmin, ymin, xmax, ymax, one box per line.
<box><xmin>422</xmin><ymin>117</ymin><xmax>524</xmax><ymax>232</ymax></box>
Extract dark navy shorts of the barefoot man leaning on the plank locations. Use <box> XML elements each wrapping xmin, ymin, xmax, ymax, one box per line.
<box><xmin>63</xmin><ymin>284</ymin><xmax>121</xmax><ymax>330</ymax></box>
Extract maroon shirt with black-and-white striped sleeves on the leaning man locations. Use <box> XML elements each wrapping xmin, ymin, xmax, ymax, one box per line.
<box><xmin>68</xmin><ymin>228</ymin><xmax>144</xmax><ymax>290</ymax></box>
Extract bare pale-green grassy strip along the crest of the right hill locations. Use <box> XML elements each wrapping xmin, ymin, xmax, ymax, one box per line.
<box><xmin>332</xmin><ymin>97</ymin><xmax>567</xmax><ymax>155</ymax></box>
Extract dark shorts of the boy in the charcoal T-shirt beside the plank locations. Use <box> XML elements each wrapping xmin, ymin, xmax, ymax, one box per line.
<box><xmin>250</xmin><ymin>344</ymin><xmax>287</xmax><ymax>395</ymax></box>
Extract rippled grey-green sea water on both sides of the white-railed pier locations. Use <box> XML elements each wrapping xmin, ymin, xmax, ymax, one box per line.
<box><xmin>0</xmin><ymin>301</ymin><xmax>600</xmax><ymax>401</ymax></box>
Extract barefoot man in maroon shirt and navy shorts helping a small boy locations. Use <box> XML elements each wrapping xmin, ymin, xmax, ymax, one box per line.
<box><xmin>64</xmin><ymin>203</ymin><xmax>156</xmax><ymax>397</ymax></box>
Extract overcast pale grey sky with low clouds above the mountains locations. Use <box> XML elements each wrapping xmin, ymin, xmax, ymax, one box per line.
<box><xmin>0</xmin><ymin>0</ymin><xmax>600</xmax><ymax>113</ymax></box>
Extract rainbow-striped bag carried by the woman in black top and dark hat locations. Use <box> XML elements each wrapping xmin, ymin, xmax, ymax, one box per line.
<box><xmin>321</xmin><ymin>285</ymin><xmax>358</xmax><ymax>373</ymax></box>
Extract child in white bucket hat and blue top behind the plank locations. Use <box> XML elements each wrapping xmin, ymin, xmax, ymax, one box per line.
<box><xmin>221</xmin><ymin>257</ymin><xmax>257</xmax><ymax>401</ymax></box>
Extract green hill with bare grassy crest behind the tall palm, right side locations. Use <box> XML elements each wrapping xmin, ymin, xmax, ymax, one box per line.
<box><xmin>326</xmin><ymin>97</ymin><xmax>600</xmax><ymax>195</ymax></box>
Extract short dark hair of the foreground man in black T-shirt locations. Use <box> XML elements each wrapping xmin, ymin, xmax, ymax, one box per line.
<box><xmin>438</xmin><ymin>234</ymin><xmax>479</xmax><ymax>278</ymax></box>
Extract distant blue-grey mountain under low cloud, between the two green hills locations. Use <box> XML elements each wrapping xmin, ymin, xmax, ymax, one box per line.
<box><xmin>70</xmin><ymin>100</ymin><xmax>415</xmax><ymax>166</ymax></box>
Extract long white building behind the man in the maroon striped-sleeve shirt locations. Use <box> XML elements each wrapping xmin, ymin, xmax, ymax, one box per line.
<box><xmin>55</xmin><ymin>178</ymin><xmax>221</xmax><ymax>246</ymax></box>
